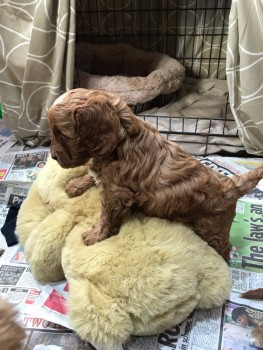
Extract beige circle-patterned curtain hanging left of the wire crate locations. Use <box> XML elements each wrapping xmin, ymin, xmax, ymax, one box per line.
<box><xmin>0</xmin><ymin>0</ymin><xmax>75</xmax><ymax>146</ymax></box>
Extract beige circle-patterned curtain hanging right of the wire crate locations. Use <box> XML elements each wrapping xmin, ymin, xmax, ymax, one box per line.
<box><xmin>227</xmin><ymin>0</ymin><xmax>263</xmax><ymax>156</ymax></box>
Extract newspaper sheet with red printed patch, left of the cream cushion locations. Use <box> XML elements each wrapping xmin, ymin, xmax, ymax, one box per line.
<box><xmin>0</xmin><ymin>245</ymin><xmax>72</xmax><ymax>328</ymax></box>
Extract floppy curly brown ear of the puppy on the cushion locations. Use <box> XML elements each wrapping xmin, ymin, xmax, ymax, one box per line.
<box><xmin>74</xmin><ymin>95</ymin><xmax>121</xmax><ymax>158</ymax></box>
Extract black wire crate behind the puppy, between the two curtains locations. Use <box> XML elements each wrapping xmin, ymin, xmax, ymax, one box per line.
<box><xmin>76</xmin><ymin>0</ymin><xmax>244</xmax><ymax>154</ymax></box>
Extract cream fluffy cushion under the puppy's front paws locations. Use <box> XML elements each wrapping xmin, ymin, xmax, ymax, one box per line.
<box><xmin>17</xmin><ymin>159</ymin><xmax>231</xmax><ymax>349</ymax></box>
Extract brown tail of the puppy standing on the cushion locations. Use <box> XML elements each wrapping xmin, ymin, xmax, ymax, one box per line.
<box><xmin>231</xmin><ymin>165</ymin><xmax>263</xmax><ymax>197</ymax></box>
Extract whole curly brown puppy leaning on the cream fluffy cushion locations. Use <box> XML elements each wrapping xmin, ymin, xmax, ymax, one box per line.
<box><xmin>49</xmin><ymin>89</ymin><xmax>263</xmax><ymax>259</ymax></box>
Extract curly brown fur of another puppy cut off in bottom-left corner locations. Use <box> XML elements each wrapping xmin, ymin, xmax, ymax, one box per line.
<box><xmin>0</xmin><ymin>300</ymin><xmax>25</xmax><ymax>350</ymax></box>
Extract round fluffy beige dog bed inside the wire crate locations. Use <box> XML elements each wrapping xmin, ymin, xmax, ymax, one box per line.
<box><xmin>75</xmin><ymin>42</ymin><xmax>185</xmax><ymax>113</ymax></box>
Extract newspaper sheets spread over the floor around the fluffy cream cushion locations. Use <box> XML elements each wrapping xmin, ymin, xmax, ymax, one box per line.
<box><xmin>0</xmin><ymin>119</ymin><xmax>263</xmax><ymax>350</ymax></box>
